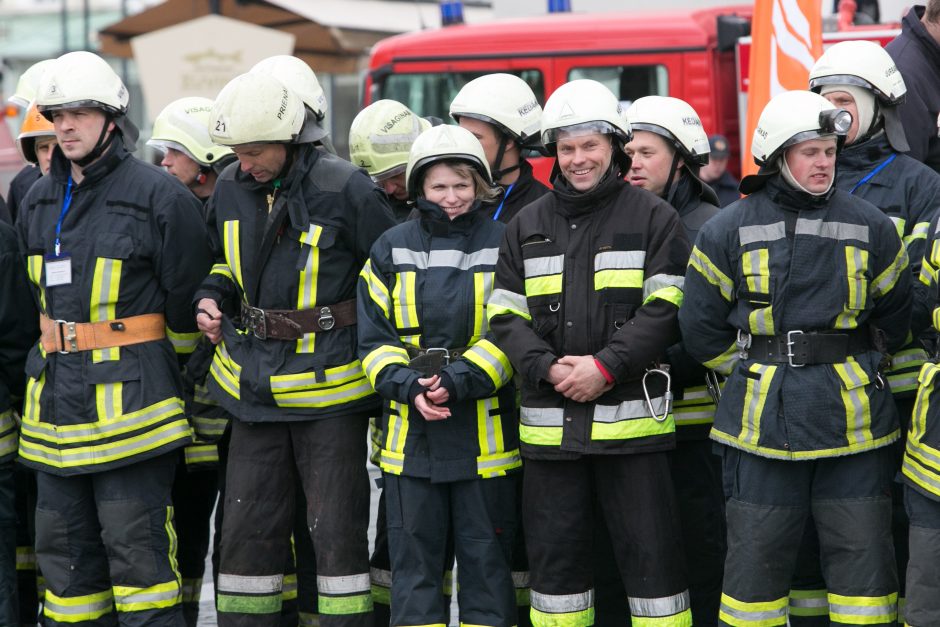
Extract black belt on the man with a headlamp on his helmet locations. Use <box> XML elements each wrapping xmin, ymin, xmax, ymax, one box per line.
<box><xmin>746</xmin><ymin>327</ymin><xmax>873</xmax><ymax>367</ymax></box>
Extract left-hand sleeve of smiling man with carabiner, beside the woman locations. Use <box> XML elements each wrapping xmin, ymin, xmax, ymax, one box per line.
<box><xmin>486</xmin><ymin>220</ymin><xmax>556</xmax><ymax>385</ymax></box>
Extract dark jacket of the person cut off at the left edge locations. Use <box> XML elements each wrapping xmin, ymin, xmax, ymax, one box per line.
<box><xmin>0</xmin><ymin>223</ymin><xmax>39</xmax><ymax>462</ymax></box>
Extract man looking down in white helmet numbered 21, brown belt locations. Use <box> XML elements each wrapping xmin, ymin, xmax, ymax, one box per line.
<box><xmin>195</xmin><ymin>72</ymin><xmax>394</xmax><ymax>627</ymax></box>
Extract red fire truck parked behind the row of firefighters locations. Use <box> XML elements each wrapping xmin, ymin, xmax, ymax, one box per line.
<box><xmin>363</xmin><ymin>5</ymin><xmax>898</xmax><ymax>180</ymax></box>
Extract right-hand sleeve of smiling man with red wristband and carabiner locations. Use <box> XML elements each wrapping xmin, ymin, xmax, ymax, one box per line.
<box><xmin>596</xmin><ymin>205</ymin><xmax>689</xmax><ymax>382</ymax></box>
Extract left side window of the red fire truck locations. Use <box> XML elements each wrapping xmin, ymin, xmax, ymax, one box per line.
<box><xmin>380</xmin><ymin>70</ymin><xmax>545</xmax><ymax>122</ymax></box>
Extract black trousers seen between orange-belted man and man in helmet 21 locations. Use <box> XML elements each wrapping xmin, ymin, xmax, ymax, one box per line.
<box><xmin>172</xmin><ymin>454</ymin><xmax>219</xmax><ymax>627</ymax></box>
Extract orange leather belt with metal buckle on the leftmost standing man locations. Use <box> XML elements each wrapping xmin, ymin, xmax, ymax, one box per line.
<box><xmin>39</xmin><ymin>314</ymin><xmax>166</xmax><ymax>354</ymax></box>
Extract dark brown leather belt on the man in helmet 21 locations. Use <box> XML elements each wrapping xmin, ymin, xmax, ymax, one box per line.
<box><xmin>242</xmin><ymin>298</ymin><xmax>356</xmax><ymax>340</ymax></box>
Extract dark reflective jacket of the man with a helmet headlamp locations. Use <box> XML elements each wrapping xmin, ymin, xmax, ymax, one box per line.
<box><xmin>679</xmin><ymin>174</ymin><xmax>912</xmax><ymax>460</ymax></box>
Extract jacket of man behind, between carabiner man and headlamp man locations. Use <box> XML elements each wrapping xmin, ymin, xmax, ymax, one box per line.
<box><xmin>666</xmin><ymin>174</ymin><xmax>719</xmax><ymax>441</ymax></box>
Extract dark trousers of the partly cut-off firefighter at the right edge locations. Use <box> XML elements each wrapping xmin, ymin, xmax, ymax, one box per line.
<box><xmin>904</xmin><ymin>485</ymin><xmax>940</xmax><ymax>627</ymax></box>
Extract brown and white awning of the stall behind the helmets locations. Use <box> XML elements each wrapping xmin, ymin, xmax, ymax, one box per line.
<box><xmin>99</xmin><ymin>0</ymin><xmax>492</xmax><ymax>74</ymax></box>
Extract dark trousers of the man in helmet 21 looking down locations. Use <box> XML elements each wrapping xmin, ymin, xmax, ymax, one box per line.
<box><xmin>216</xmin><ymin>416</ymin><xmax>372</xmax><ymax>627</ymax></box>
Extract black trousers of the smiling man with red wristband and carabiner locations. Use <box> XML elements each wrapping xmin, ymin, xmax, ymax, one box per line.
<box><xmin>523</xmin><ymin>453</ymin><xmax>692</xmax><ymax>627</ymax></box>
